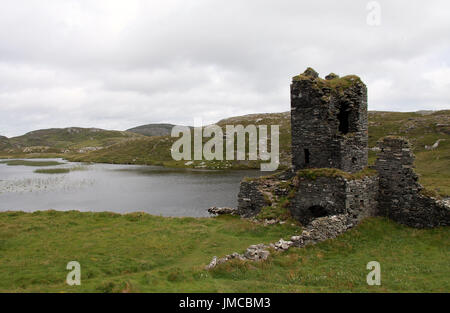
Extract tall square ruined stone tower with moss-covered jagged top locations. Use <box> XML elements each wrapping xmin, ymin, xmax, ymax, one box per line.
<box><xmin>291</xmin><ymin>68</ymin><xmax>368</xmax><ymax>173</ymax></box>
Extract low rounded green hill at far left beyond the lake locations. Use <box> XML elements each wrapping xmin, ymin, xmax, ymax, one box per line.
<box><xmin>0</xmin><ymin>127</ymin><xmax>140</xmax><ymax>153</ymax></box>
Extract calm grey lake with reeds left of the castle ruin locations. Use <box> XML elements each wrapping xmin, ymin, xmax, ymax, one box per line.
<box><xmin>0</xmin><ymin>159</ymin><xmax>267</xmax><ymax>217</ymax></box>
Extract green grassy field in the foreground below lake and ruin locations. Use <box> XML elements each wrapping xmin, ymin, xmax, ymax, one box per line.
<box><xmin>0</xmin><ymin>211</ymin><xmax>450</xmax><ymax>292</ymax></box>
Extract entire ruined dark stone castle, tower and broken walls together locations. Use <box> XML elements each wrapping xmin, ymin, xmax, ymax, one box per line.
<box><xmin>238</xmin><ymin>68</ymin><xmax>450</xmax><ymax>228</ymax></box>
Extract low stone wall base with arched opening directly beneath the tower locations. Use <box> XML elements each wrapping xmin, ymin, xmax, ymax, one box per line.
<box><xmin>289</xmin><ymin>175</ymin><xmax>378</xmax><ymax>225</ymax></box>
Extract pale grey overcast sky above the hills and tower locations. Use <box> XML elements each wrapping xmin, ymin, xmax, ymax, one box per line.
<box><xmin>0</xmin><ymin>0</ymin><xmax>450</xmax><ymax>137</ymax></box>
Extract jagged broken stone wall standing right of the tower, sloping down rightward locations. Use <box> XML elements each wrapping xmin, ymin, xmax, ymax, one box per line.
<box><xmin>376</xmin><ymin>137</ymin><xmax>450</xmax><ymax>228</ymax></box>
